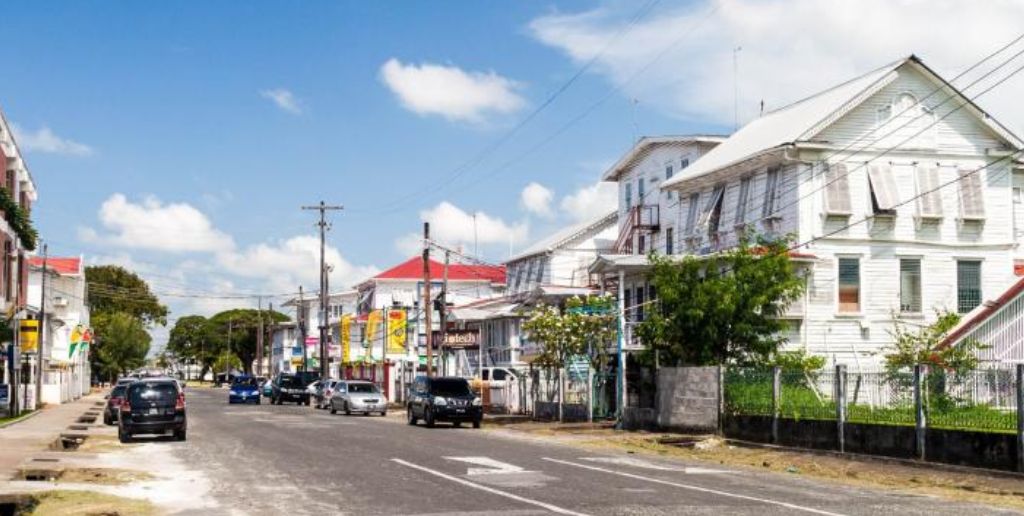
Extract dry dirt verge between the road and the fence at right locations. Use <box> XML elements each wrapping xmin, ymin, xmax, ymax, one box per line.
<box><xmin>490</xmin><ymin>422</ymin><xmax>1024</xmax><ymax>510</ymax></box>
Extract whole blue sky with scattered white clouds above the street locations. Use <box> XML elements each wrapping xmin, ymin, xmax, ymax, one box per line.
<box><xmin>0</xmin><ymin>0</ymin><xmax>1024</xmax><ymax>346</ymax></box>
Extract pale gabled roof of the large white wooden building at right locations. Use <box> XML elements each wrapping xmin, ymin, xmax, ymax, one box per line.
<box><xmin>662</xmin><ymin>55</ymin><xmax>1024</xmax><ymax>188</ymax></box>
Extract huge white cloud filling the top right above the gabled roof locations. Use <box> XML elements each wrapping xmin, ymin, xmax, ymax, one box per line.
<box><xmin>529</xmin><ymin>0</ymin><xmax>1024</xmax><ymax>133</ymax></box>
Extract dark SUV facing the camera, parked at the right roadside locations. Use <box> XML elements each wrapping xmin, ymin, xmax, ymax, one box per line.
<box><xmin>407</xmin><ymin>377</ymin><xmax>483</xmax><ymax>428</ymax></box>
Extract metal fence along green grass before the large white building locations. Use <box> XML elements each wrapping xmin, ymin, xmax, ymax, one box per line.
<box><xmin>724</xmin><ymin>367</ymin><xmax>1017</xmax><ymax>433</ymax></box>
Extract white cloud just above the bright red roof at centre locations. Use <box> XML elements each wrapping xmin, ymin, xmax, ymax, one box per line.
<box><xmin>395</xmin><ymin>201</ymin><xmax>529</xmax><ymax>255</ymax></box>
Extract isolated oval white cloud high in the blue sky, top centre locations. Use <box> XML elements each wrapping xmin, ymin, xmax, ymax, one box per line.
<box><xmin>380</xmin><ymin>57</ymin><xmax>525</xmax><ymax>122</ymax></box>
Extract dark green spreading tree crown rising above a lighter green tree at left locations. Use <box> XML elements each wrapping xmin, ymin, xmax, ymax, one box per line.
<box><xmin>85</xmin><ymin>265</ymin><xmax>168</xmax><ymax>323</ymax></box>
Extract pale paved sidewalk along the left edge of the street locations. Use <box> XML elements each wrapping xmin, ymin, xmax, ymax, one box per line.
<box><xmin>0</xmin><ymin>394</ymin><xmax>103</xmax><ymax>482</ymax></box>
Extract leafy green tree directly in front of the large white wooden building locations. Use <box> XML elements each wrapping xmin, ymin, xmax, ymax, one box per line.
<box><xmin>636</xmin><ymin>240</ymin><xmax>804</xmax><ymax>366</ymax></box>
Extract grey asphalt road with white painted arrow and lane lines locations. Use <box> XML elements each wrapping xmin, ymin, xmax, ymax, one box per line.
<box><xmin>174</xmin><ymin>389</ymin><xmax>1019</xmax><ymax>516</ymax></box>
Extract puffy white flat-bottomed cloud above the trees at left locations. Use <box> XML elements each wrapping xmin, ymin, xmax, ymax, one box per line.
<box><xmin>79</xmin><ymin>194</ymin><xmax>234</xmax><ymax>253</ymax></box>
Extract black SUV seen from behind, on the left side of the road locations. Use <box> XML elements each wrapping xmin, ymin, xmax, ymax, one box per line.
<box><xmin>118</xmin><ymin>378</ymin><xmax>187</xmax><ymax>442</ymax></box>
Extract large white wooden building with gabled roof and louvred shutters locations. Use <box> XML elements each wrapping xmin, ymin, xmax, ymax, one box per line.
<box><xmin>662</xmin><ymin>56</ymin><xmax>1024</xmax><ymax>368</ymax></box>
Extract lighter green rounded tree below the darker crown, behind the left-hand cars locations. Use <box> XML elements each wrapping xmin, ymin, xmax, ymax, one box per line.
<box><xmin>92</xmin><ymin>312</ymin><xmax>151</xmax><ymax>381</ymax></box>
